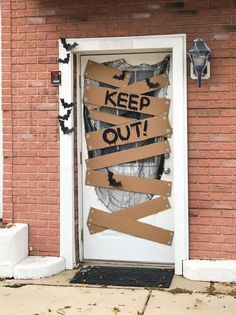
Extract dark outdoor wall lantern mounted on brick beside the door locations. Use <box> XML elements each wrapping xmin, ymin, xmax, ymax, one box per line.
<box><xmin>187</xmin><ymin>38</ymin><xmax>211</xmax><ymax>87</ymax></box>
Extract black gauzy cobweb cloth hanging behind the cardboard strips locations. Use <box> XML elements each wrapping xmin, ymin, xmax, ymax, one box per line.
<box><xmin>83</xmin><ymin>55</ymin><xmax>170</xmax><ymax>212</ymax></box>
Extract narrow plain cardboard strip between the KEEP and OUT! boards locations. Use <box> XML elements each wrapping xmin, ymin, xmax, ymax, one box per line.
<box><xmin>89</xmin><ymin>110</ymin><xmax>136</xmax><ymax>125</ymax></box>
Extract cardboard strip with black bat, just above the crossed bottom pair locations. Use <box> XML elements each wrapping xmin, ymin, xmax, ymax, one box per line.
<box><xmin>85</xmin><ymin>171</ymin><xmax>171</xmax><ymax>196</ymax></box>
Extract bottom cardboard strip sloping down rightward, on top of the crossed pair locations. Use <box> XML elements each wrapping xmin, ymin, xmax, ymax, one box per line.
<box><xmin>88</xmin><ymin>208</ymin><xmax>174</xmax><ymax>245</ymax></box>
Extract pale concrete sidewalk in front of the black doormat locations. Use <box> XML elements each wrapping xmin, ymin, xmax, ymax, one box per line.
<box><xmin>0</xmin><ymin>270</ymin><xmax>236</xmax><ymax>315</ymax></box>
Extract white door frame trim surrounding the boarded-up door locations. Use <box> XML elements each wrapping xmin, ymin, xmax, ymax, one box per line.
<box><xmin>59</xmin><ymin>34</ymin><xmax>189</xmax><ymax>274</ymax></box>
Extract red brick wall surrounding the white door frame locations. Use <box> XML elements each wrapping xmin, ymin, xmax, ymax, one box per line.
<box><xmin>2</xmin><ymin>0</ymin><xmax>236</xmax><ymax>259</ymax></box>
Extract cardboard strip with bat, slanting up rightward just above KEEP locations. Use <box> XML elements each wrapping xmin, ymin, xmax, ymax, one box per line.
<box><xmin>119</xmin><ymin>74</ymin><xmax>170</xmax><ymax>94</ymax></box>
